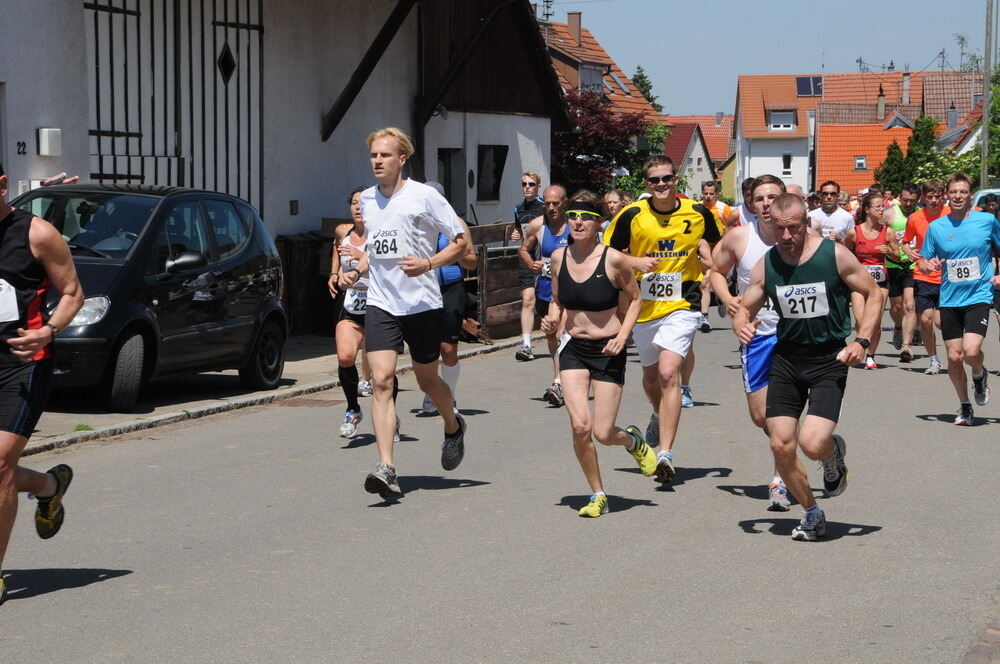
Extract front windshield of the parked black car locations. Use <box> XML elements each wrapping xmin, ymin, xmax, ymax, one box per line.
<box><xmin>17</xmin><ymin>190</ymin><xmax>160</xmax><ymax>259</ymax></box>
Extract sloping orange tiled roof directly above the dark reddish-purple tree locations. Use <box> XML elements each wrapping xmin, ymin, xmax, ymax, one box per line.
<box><xmin>539</xmin><ymin>21</ymin><xmax>658</xmax><ymax>120</ymax></box>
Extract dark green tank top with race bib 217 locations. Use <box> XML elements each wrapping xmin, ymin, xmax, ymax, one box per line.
<box><xmin>764</xmin><ymin>240</ymin><xmax>851</xmax><ymax>346</ymax></box>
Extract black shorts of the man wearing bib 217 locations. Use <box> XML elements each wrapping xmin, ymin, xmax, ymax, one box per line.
<box><xmin>767</xmin><ymin>341</ymin><xmax>847</xmax><ymax>422</ymax></box>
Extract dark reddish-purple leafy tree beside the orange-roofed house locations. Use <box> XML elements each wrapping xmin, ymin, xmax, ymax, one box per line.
<box><xmin>552</xmin><ymin>89</ymin><xmax>650</xmax><ymax>193</ymax></box>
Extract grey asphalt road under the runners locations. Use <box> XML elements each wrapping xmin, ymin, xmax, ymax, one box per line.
<box><xmin>0</xmin><ymin>318</ymin><xmax>1000</xmax><ymax>663</ymax></box>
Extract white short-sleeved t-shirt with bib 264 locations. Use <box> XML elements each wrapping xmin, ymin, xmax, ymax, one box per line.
<box><xmin>361</xmin><ymin>180</ymin><xmax>465</xmax><ymax>316</ymax></box>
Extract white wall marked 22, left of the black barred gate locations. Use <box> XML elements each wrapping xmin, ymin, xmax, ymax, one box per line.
<box><xmin>0</xmin><ymin>0</ymin><xmax>90</xmax><ymax>192</ymax></box>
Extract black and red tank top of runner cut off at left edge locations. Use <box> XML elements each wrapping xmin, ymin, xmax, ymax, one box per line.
<box><xmin>0</xmin><ymin>210</ymin><xmax>51</xmax><ymax>367</ymax></box>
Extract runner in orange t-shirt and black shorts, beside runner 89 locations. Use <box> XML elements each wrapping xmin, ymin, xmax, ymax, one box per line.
<box><xmin>902</xmin><ymin>179</ymin><xmax>951</xmax><ymax>376</ymax></box>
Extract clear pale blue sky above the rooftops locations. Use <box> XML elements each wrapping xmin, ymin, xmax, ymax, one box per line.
<box><xmin>548</xmin><ymin>0</ymin><xmax>997</xmax><ymax>115</ymax></box>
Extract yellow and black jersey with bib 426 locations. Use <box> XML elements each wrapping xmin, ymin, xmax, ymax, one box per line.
<box><xmin>604</xmin><ymin>198</ymin><xmax>722</xmax><ymax>323</ymax></box>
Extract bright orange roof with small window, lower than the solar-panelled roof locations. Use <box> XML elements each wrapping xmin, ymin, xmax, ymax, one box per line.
<box><xmin>816</xmin><ymin>123</ymin><xmax>912</xmax><ymax>193</ymax></box>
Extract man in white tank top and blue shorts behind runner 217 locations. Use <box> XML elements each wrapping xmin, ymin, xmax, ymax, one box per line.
<box><xmin>711</xmin><ymin>175</ymin><xmax>791</xmax><ymax>512</ymax></box>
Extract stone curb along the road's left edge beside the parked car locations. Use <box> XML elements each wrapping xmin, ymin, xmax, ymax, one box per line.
<box><xmin>21</xmin><ymin>332</ymin><xmax>545</xmax><ymax>457</ymax></box>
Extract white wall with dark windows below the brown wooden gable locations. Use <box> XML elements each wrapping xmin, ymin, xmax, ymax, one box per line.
<box><xmin>423</xmin><ymin>112</ymin><xmax>551</xmax><ymax>224</ymax></box>
